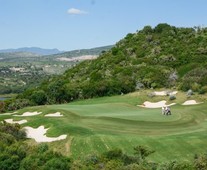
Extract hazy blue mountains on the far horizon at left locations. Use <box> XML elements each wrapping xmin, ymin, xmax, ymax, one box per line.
<box><xmin>0</xmin><ymin>47</ymin><xmax>64</xmax><ymax>55</ymax></box>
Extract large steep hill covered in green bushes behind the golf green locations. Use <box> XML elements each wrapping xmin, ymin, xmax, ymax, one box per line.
<box><xmin>16</xmin><ymin>24</ymin><xmax>207</xmax><ymax>104</ymax></box>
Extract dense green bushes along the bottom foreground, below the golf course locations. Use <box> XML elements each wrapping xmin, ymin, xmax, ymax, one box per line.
<box><xmin>0</xmin><ymin>122</ymin><xmax>207</xmax><ymax>170</ymax></box>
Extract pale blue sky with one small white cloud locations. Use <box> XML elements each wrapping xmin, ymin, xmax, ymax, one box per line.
<box><xmin>0</xmin><ymin>0</ymin><xmax>207</xmax><ymax>51</ymax></box>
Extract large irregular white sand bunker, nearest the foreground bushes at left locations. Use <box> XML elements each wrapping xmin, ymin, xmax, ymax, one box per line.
<box><xmin>24</xmin><ymin>126</ymin><xmax>67</xmax><ymax>142</ymax></box>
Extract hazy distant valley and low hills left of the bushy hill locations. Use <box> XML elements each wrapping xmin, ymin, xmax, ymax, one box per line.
<box><xmin>0</xmin><ymin>46</ymin><xmax>112</xmax><ymax>94</ymax></box>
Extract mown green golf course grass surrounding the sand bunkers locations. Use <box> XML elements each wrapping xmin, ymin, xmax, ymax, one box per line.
<box><xmin>0</xmin><ymin>91</ymin><xmax>207</xmax><ymax>161</ymax></box>
